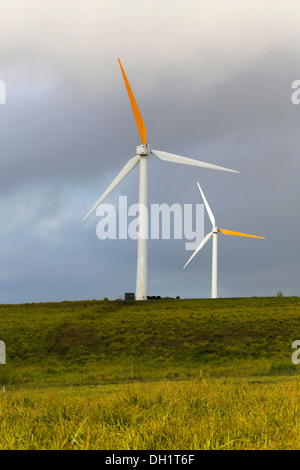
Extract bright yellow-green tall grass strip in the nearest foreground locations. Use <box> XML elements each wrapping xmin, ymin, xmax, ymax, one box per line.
<box><xmin>0</xmin><ymin>377</ymin><xmax>300</xmax><ymax>450</ymax></box>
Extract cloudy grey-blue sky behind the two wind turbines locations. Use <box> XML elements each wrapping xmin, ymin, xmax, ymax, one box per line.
<box><xmin>0</xmin><ymin>0</ymin><xmax>300</xmax><ymax>303</ymax></box>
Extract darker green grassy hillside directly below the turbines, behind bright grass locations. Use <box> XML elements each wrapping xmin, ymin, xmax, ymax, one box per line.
<box><xmin>0</xmin><ymin>297</ymin><xmax>300</xmax><ymax>384</ymax></box>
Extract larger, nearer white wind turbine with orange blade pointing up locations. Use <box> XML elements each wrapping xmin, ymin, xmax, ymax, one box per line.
<box><xmin>83</xmin><ymin>59</ymin><xmax>239</xmax><ymax>300</ymax></box>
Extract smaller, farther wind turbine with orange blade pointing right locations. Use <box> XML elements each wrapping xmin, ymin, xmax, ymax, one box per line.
<box><xmin>183</xmin><ymin>183</ymin><xmax>265</xmax><ymax>299</ymax></box>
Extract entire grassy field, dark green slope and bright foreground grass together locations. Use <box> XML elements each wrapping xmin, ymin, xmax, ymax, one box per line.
<box><xmin>0</xmin><ymin>297</ymin><xmax>300</xmax><ymax>450</ymax></box>
